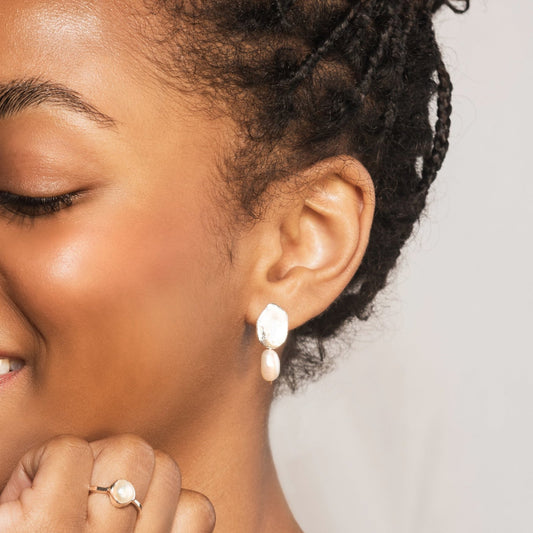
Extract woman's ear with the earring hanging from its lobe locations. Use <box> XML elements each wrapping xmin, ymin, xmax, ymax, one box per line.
<box><xmin>246</xmin><ymin>156</ymin><xmax>375</xmax><ymax>329</ymax></box>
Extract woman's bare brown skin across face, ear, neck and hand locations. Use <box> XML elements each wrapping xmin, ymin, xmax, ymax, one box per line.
<box><xmin>0</xmin><ymin>0</ymin><xmax>374</xmax><ymax>533</ymax></box>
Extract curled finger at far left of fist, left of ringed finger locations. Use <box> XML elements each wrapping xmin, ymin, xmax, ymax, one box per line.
<box><xmin>0</xmin><ymin>436</ymin><xmax>93</xmax><ymax>531</ymax></box>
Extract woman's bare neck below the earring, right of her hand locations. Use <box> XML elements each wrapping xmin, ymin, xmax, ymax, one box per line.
<box><xmin>156</xmin><ymin>376</ymin><xmax>301</xmax><ymax>533</ymax></box>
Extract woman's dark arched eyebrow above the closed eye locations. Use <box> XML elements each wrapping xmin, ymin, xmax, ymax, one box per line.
<box><xmin>0</xmin><ymin>78</ymin><xmax>117</xmax><ymax>128</ymax></box>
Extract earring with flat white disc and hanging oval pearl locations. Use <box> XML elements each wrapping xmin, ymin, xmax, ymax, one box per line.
<box><xmin>256</xmin><ymin>304</ymin><xmax>289</xmax><ymax>381</ymax></box>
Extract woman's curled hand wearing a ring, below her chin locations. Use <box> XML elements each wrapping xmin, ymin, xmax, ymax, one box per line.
<box><xmin>0</xmin><ymin>435</ymin><xmax>215</xmax><ymax>533</ymax></box>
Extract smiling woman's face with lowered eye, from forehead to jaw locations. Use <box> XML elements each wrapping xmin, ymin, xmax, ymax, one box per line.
<box><xmin>0</xmin><ymin>0</ymin><xmax>243</xmax><ymax>483</ymax></box>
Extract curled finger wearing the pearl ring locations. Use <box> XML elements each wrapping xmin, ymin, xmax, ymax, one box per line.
<box><xmin>88</xmin><ymin>434</ymin><xmax>155</xmax><ymax>532</ymax></box>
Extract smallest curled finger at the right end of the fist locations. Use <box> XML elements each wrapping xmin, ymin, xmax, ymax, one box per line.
<box><xmin>172</xmin><ymin>489</ymin><xmax>216</xmax><ymax>533</ymax></box>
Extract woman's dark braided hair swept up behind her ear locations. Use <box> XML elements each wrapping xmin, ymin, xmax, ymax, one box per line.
<box><xmin>142</xmin><ymin>0</ymin><xmax>469</xmax><ymax>390</ymax></box>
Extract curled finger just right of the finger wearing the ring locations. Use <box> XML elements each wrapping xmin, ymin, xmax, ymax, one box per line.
<box><xmin>135</xmin><ymin>450</ymin><xmax>181</xmax><ymax>533</ymax></box>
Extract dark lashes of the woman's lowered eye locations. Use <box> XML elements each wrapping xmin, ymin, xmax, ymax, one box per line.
<box><xmin>0</xmin><ymin>191</ymin><xmax>80</xmax><ymax>219</ymax></box>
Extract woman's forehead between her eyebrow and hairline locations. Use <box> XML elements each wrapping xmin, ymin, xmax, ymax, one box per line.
<box><xmin>0</xmin><ymin>0</ymin><xmax>166</xmax><ymax>127</ymax></box>
